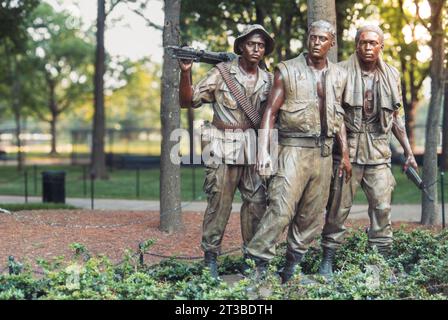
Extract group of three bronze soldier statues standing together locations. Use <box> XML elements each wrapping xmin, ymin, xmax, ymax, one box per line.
<box><xmin>179</xmin><ymin>20</ymin><xmax>417</xmax><ymax>283</ymax></box>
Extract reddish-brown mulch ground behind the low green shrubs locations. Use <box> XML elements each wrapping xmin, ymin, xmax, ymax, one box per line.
<box><xmin>0</xmin><ymin>210</ymin><xmax>435</xmax><ymax>272</ymax></box>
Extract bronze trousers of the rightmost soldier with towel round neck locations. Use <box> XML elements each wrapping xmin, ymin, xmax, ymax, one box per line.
<box><xmin>322</xmin><ymin>163</ymin><xmax>396</xmax><ymax>249</ymax></box>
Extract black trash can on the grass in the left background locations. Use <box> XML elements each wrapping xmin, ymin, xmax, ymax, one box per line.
<box><xmin>42</xmin><ymin>171</ymin><xmax>65</xmax><ymax>203</ymax></box>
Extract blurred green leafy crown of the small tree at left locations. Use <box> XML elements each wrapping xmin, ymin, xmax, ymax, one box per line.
<box><xmin>27</xmin><ymin>3</ymin><xmax>94</xmax><ymax>122</ymax></box>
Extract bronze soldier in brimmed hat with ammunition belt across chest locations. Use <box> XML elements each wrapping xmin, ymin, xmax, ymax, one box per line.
<box><xmin>176</xmin><ymin>24</ymin><xmax>274</xmax><ymax>277</ymax></box>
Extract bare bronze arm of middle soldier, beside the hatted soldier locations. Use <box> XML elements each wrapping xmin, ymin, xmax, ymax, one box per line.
<box><xmin>257</xmin><ymin>70</ymin><xmax>285</xmax><ymax>172</ymax></box>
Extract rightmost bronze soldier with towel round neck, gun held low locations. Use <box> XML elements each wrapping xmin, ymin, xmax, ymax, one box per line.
<box><xmin>319</xmin><ymin>26</ymin><xmax>424</xmax><ymax>277</ymax></box>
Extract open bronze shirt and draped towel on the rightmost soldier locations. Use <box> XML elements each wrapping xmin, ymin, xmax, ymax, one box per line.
<box><xmin>335</xmin><ymin>54</ymin><xmax>402</xmax><ymax>165</ymax></box>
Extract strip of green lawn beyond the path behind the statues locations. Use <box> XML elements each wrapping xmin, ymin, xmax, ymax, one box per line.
<box><xmin>0</xmin><ymin>166</ymin><xmax>448</xmax><ymax>204</ymax></box>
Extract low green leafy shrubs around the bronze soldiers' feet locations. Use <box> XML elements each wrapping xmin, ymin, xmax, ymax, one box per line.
<box><xmin>0</xmin><ymin>229</ymin><xmax>448</xmax><ymax>300</ymax></box>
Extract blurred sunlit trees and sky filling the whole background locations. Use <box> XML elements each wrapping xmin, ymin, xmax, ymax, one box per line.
<box><xmin>0</xmin><ymin>0</ymin><xmax>448</xmax><ymax>225</ymax></box>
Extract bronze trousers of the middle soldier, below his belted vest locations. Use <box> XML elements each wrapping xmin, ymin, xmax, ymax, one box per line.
<box><xmin>246</xmin><ymin>146</ymin><xmax>332</xmax><ymax>260</ymax></box>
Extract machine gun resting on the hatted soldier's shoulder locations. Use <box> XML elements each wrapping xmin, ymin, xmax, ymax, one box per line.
<box><xmin>166</xmin><ymin>46</ymin><xmax>238</xmax><ymax>64</ymax></box>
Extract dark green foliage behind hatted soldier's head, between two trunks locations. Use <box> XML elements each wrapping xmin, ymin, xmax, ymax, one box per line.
<box><xmin>181</xmin><ymin>0</ymin><xmax>307</xmax><ymax>62</ymax></box>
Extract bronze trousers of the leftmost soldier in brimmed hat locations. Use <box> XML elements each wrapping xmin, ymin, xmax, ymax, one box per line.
<box><xmin>201</xmin><ymin>164</ymin><xmax>266</xmax><ymax>253</ymax></box>
